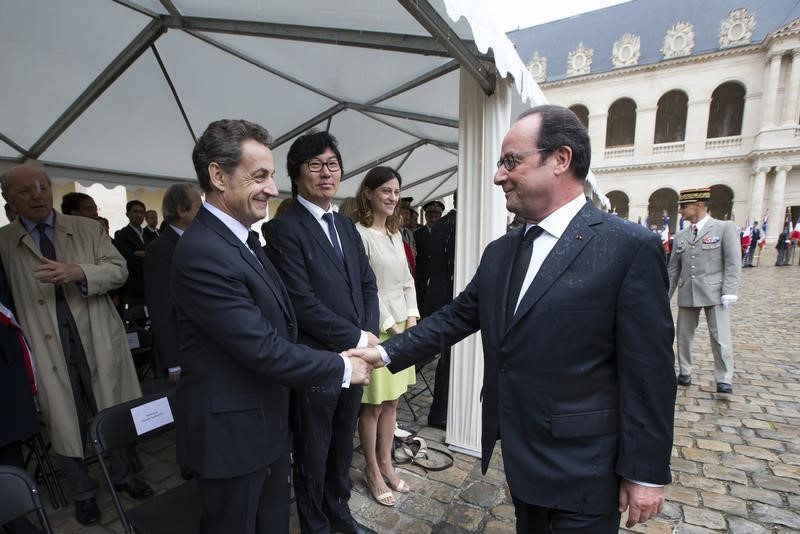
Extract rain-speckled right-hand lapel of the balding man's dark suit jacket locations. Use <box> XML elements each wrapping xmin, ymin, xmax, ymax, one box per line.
<box><xmin>506</xmin><ymin>202</ymin><xmax>600</xmax><ymax>331</ymax></box>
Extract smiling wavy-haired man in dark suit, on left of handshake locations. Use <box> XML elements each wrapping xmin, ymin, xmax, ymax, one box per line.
<box><xmin>172</xmin><ymin>120</ymin><xmax>371</xmax><ymax>534</ymax></box>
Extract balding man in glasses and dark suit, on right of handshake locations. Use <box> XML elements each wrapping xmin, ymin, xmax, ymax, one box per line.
<box><xmin>353</xmin><ymin>106</ymin><xmax>676</xmax><ymax>534</ymax></box>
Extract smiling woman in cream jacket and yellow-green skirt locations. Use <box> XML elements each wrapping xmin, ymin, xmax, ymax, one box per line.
<box><xmin>356</xmin><ymin>167</ymin><xmax>419</xmax><ymax>506</ymax></box>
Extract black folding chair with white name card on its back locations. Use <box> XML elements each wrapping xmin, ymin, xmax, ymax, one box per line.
<box><xmin>89</xmin><ymin>394</ymin><xmax>200</xmax><ymax>534</ymax></box>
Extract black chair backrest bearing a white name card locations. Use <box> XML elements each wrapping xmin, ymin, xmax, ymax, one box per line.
<box><xmin>89</xmin><ymin>393</ymin><xmax>174</xmax><ymax>454</ymax></box>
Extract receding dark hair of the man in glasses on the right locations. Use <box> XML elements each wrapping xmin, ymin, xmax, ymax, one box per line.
<box><xmin>517</xmin><ymin>105</ymin><xmax>592</xmax><ymax>180</ymax></box>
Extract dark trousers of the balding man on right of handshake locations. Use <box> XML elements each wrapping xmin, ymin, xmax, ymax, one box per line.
<box><xmin>511</xmin><ymin>495</ymin><xmax>621</xmax><ymax>534</ymax></box>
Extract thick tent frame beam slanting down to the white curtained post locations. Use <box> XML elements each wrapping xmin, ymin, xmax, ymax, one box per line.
<box><xmin>397</xmin><ymin>0</ymin><xmax>497</xmax><ymax>95</ymax></box>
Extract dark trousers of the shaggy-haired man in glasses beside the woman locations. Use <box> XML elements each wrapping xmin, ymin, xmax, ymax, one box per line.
<box><xmin>290</xmin><ymin>385</ymin><xmax>363</xmax><ymax>534</ymax></box>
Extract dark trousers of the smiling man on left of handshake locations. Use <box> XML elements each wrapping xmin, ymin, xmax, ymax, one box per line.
<box><xmin>197</xmin><ymin>450</ymin><xmax>290</xmax><ymax>534</ymax></box>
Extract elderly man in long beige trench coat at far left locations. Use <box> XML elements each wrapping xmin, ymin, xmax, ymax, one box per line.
<box><xmin>0</xmin><ymin>165</ymin><xmax>152</xmax><ymax>524</ymax></box>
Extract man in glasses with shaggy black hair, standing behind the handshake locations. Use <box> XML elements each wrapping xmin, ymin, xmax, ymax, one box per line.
<box><xmin>267</xmin><ymin>130</ymin><xmax>379</xmax><ymax>534</ymax></box>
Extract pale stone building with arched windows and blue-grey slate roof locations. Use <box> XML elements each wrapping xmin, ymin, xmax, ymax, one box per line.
<box><xmin>509</xmin><ymin>0</ymin><xmax>800</xmax><ymax>239</ymax></box>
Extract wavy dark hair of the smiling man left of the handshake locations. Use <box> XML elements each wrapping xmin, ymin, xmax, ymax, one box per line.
<box><xmin>192</xmin><ymin>119</ymin><xmax>272</xmax><ymax>193</ymax></box>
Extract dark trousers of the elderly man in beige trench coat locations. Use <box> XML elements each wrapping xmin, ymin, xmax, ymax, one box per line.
<box><xmin>56</xmin><ymin>298</ymin><xmax>134</xmax><ymax>501</ymax></box>
